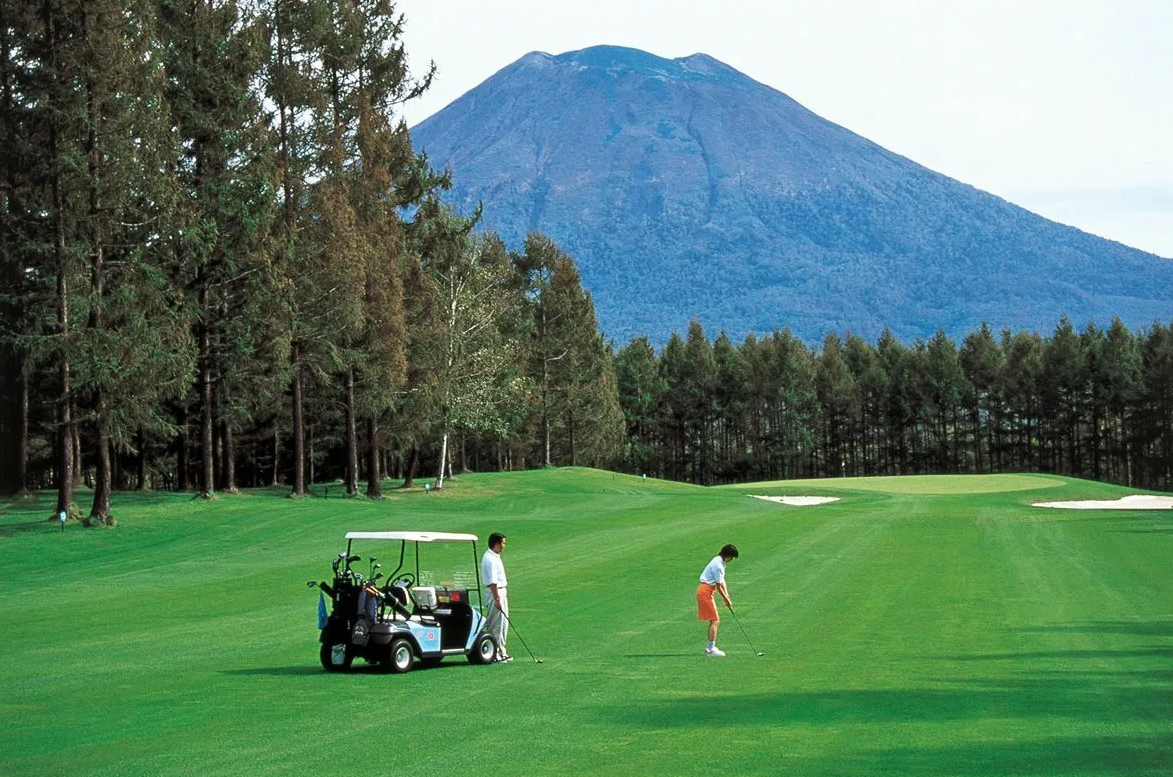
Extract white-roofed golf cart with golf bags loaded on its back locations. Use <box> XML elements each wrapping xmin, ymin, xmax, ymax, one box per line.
<box><xmin>308</xmin><ymin>532</ymin><xmax>497</xmax><ymax>673</ymax></box>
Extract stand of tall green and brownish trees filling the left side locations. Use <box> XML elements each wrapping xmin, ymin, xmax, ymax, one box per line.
<box><xmin>0</xmin><ymin>0</ymin><xmax>623</xmax><ymax>525</ymax></box>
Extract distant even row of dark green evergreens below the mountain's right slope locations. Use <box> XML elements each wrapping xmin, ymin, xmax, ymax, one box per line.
<box><xmin>616</xmin><ymin>318</ymin><xmax>1173</xmax><ymax>491</ymax></box>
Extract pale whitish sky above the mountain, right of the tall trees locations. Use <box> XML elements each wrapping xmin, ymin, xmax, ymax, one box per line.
<box><xmin>396</xmin><ymin>0</ymin><xmax>1173</xmax><ymax>257</ymax></box>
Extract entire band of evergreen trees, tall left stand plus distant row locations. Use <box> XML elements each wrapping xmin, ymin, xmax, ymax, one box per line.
<box><xmin>0</xmin><ymin>0</ymin><xmax>1173</xmax><ymax>525</ymax></box>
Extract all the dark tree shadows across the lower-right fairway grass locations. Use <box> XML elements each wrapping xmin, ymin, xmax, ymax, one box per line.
<box><xmin>601</xmin><ymin>619</ymin><xmax>1173</xmax><ymax>777</ymax></box>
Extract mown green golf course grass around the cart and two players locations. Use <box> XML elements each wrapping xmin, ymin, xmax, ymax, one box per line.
<box><xmin>0</xmin><ymin>469</ymin><xmax>1173</xmax><ymax>777</ymax></box>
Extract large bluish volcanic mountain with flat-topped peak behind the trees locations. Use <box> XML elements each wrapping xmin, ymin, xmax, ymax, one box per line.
<box><xmin>411</xmin><ymin>46</ymin><xmax>1173</xmax><ymax>345</ymax></box>
